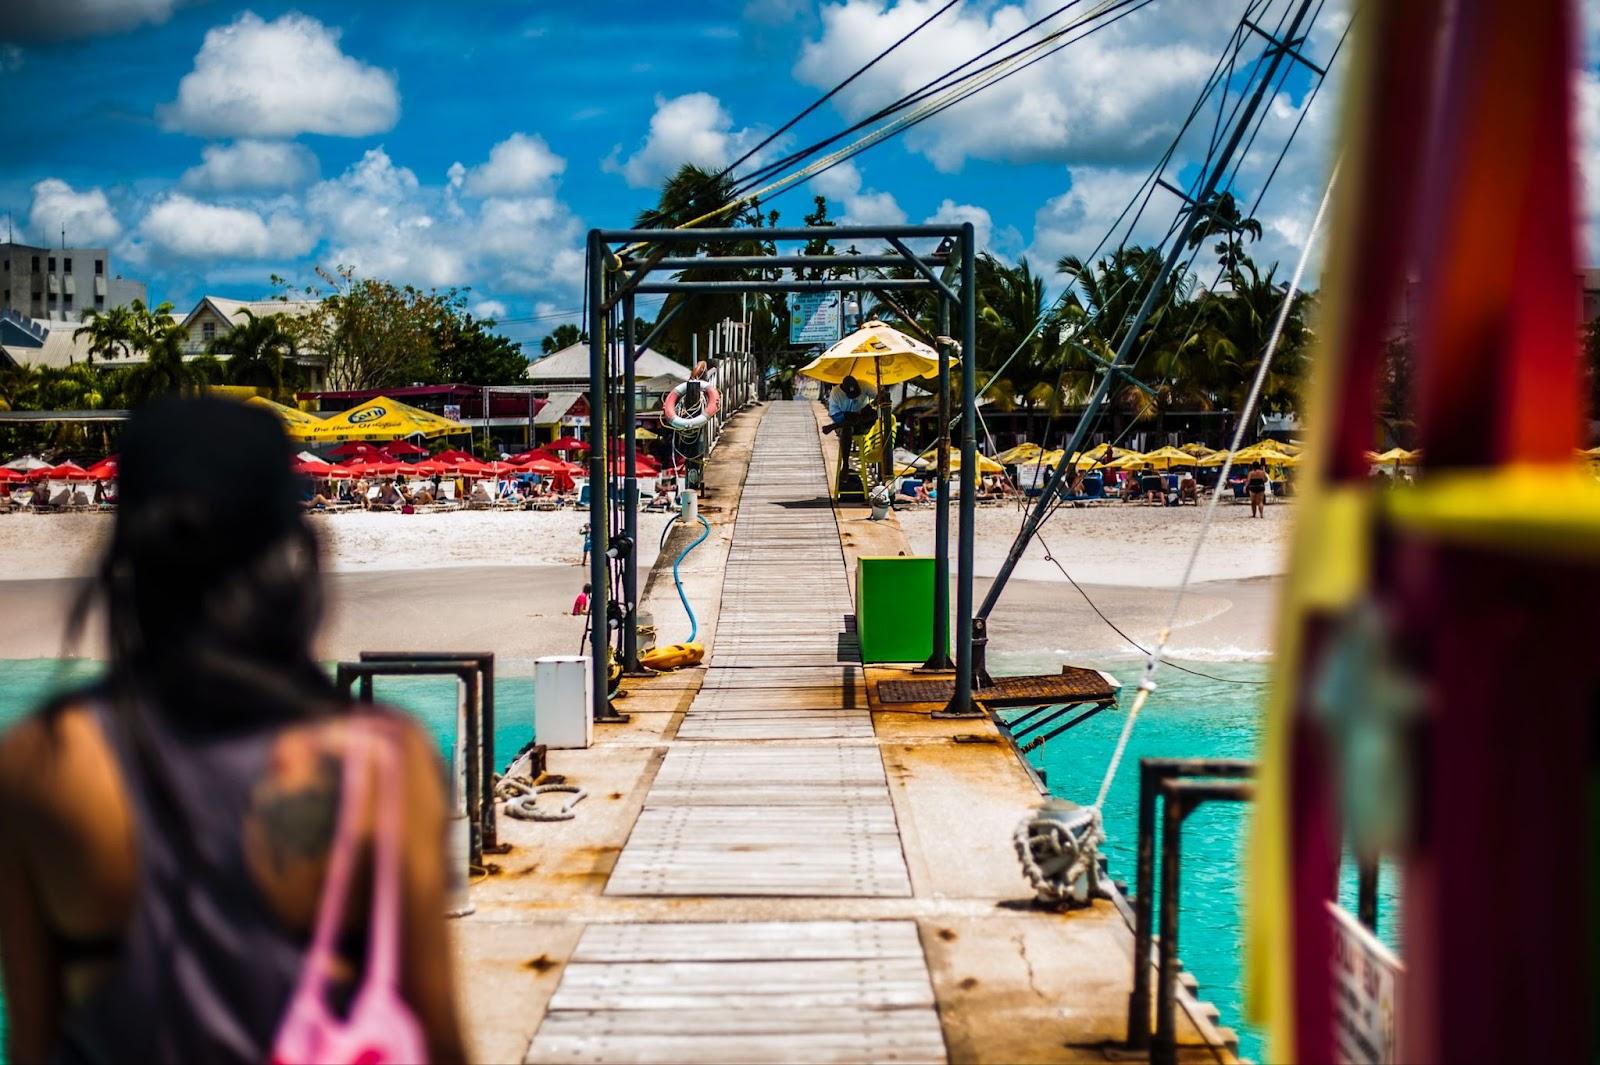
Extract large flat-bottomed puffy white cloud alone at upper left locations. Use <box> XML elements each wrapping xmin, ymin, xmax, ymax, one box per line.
<box><xmin>160</xmin><ymin>11</ymin><xmax>400</xmax><ymax>139</ymax></box>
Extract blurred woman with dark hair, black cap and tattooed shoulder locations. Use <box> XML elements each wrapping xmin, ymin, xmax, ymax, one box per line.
<box><xmin>0</xmin><ymin>400</ymin><xmax>464</xmax><ymax>1062</ymax></box>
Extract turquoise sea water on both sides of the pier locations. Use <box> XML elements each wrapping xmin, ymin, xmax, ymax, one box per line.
<box><xmin>0</xmin><ymin>656</ymin><xmax>1400</xmax><ymax>1060</ymax></box>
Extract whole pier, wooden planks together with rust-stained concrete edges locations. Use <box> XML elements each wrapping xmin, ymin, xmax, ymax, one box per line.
<box><xmin>456</xmin><ymin>403</ymin><xmax>1230</xmax><ymax>1062</ymax></box>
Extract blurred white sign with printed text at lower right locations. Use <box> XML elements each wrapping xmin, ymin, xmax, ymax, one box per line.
<box><xmin>1328</xmin><ymin>902</ymin><xmax>1403</xmax><ymax>1065</ymax></box>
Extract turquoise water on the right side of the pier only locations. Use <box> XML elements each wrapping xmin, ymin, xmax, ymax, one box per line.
<box><xmin>994</xmin><ymin>656</ymin><xmax>1400</xmax><ymax>1062</ymax></box>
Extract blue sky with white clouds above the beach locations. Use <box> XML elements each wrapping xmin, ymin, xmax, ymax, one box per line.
<box><xmin>0</xmin><ymin>0</ymin><xmax>1376</xmax><ymax>344</ymax></box>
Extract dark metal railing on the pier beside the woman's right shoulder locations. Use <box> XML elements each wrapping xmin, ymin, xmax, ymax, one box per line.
<box><xmin>334</xmin><ymin>651</ymin><xmax>501</xmax><ymax>867</ymax></box>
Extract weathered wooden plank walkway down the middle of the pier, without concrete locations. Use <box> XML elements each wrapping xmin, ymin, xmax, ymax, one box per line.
<box><xmin>528</xmin><ymin>403</ymin><xmax>946</xmax><ymax>1062</ymax></box>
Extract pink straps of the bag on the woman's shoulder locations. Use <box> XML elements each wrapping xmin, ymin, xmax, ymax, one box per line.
<box><xmin>301</xmin><ymin>721</ymin><xmax>400</xmax><ymax>998</ymax></box>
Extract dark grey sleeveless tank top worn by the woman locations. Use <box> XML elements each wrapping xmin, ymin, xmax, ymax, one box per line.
<box><xmin>58</xmin><ymin>704</ymin><xmax>340</xmax><ymax>1062</ymax></box>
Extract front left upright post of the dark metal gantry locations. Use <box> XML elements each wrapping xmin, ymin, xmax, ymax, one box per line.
<box><xmin>589</xmin><ymin>229</ymin><xmax>611</xmax><ymax>721</ymax></box>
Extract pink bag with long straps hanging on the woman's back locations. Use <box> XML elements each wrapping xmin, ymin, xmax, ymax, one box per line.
<box><xmin>272</xmin><ymin>723</ymin><xmax>427</xmax><ymax>1065</ymax></box>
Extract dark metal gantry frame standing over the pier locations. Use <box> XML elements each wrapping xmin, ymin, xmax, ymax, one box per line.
<box><xmin>587</xmin><ymin>222</ymin><xmax>979</xmax><ymax>721</ymax></box>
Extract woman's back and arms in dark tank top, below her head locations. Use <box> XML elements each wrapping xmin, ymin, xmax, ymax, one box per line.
<box><xmin>0</xmin><ymin>702</ymin><xmax>454</xmax><ymax>1062</ymax></box>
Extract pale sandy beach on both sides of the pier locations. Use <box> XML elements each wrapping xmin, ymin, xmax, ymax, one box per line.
<box><xmin>0</xmin><ymin>492</ymin><xmax>1294</xmax><ymax>658</ymax></box>
